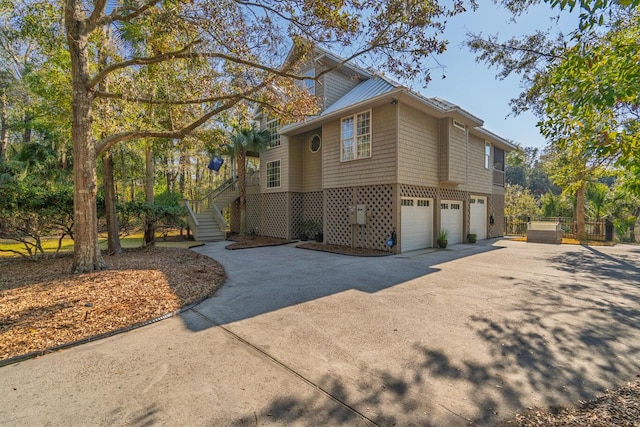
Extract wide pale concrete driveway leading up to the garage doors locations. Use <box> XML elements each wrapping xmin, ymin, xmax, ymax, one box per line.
<box><xmin>0</xmin><ymin>240</ymin><xmax>640</xmax><ymax>426</ymax></box>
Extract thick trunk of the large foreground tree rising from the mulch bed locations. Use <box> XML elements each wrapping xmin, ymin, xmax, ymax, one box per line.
<box><xmin>65</xmin><ymin>5</ymin><xmax>106</xmax><ymax>273</ymax></box>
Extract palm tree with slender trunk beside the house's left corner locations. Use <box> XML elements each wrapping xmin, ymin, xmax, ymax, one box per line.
<box><xmin>223</xmin><ymin>124</ymin><xmax>271</xmax><ymax>236</ymax></box>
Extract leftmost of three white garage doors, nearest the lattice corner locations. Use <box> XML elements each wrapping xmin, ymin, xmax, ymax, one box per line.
<box><xmin>400</xmin><ymin>198</ymin><xmax>433</xmax><ymax>252</ymax></box>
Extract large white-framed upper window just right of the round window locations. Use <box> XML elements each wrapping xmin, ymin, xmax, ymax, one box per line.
<box><xmin>340</xmin><ymin>110</ymin><xmax>371</xmax><ymax>162</ymax></box>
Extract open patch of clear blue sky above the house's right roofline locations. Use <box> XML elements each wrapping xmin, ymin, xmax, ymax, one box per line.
<box><xmin>413</xmin><ymin>0</ymin><xmax>578</xmax><ymax>148</ymax></box>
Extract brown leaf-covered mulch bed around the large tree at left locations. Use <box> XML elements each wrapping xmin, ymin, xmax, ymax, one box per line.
<box><xmin>0</xmin><ymin>247</ymin><xmax>225</xmax><ymax>361</ymax></box>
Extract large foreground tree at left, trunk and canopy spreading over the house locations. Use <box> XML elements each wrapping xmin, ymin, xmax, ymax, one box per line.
<box><xmin>12</xmin><ymin>0</ymin><xmax>475</xmax><ymax>272</ymax></box>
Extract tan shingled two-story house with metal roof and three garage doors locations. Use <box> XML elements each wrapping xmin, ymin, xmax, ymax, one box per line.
<box><xmin>231</xmin><ymin>50</ymin><xmax>515</xmax><ymax>253</ymax></box>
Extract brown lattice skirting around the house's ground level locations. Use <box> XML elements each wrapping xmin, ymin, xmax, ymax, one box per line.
<box><xmin>248</xmin><ymin>185</ymin><xmax>504</xmax><ymax>244</ymax></box>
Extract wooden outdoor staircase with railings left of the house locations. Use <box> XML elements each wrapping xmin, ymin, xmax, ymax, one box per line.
<box><xmin>185</xmin><ymin>179</ymin><xmax>239</xmax><ymax>242</ymax></box>
